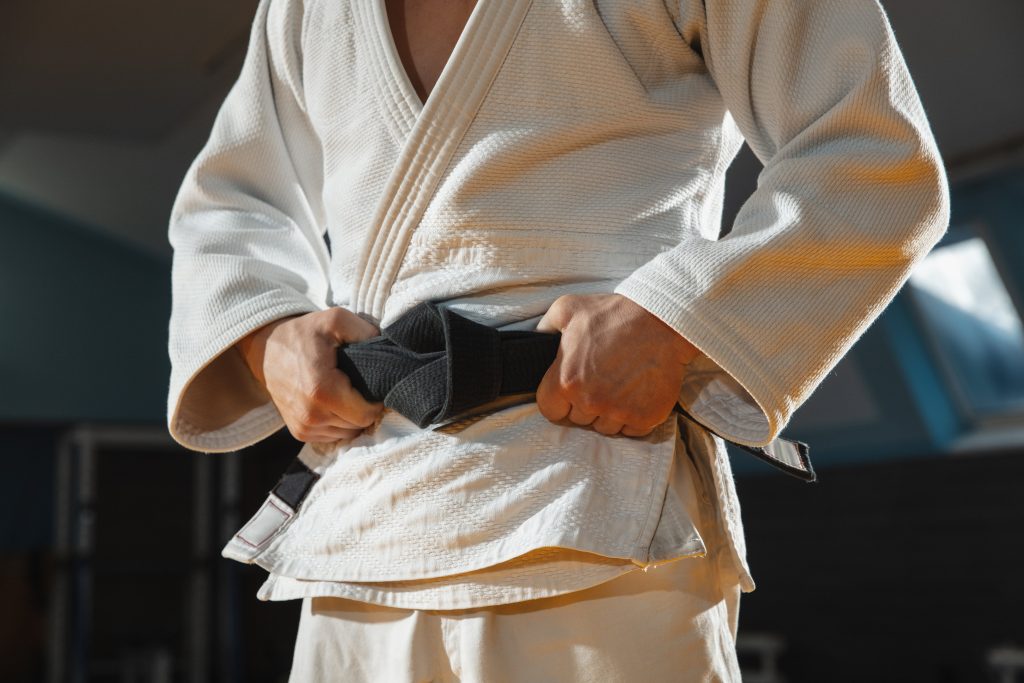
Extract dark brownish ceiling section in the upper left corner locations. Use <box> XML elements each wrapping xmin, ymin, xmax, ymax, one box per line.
<box><xmin>0</xmin><ymin>0</ymin><xmax>255</xmax><ymax>144</ymax></box>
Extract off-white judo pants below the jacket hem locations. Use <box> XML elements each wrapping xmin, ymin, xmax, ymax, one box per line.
<box><xmin>289</xmin><ymin>450</ymin><xmax>740</xmax><ymax>683</ymax></box>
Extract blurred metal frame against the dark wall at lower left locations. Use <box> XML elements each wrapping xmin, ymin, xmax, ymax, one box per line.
<box><xmin>46</xmin><ymin>425</ymin><xmax>242</xmax><ymax>683</ymax></box>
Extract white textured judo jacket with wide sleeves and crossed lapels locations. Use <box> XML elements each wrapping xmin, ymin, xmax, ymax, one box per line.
<box><xmin>168</xmin><ymin>0</ymin><xmax>949</xmax><ymax>608</ymax></box>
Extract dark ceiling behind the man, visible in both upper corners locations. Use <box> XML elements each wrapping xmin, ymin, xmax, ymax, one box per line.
<box><xmin>0</xmin><ymin>0</ymin><xmax>1024</xmax><ymax>255</ymax></box>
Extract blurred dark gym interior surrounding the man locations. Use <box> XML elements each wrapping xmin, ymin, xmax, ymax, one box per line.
<box><xmin>0</xmin><ymin>0</ymin><xmax>1024</xmax><ymax>683</ymax></box>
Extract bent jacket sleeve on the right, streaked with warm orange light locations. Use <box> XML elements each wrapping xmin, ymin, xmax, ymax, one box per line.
<box><xmin>614</xmin><ymin>0</ymin><xmax>949</xmax><ymax>445</ymax></box>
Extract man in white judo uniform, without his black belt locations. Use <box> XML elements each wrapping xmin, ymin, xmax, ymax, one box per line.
<box><xmin>168</xmin><ymin>0</ymin><xmax>949</xmax><ymax>682</ymax></box>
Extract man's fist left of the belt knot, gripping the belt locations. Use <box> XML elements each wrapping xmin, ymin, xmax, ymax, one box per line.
<box><xmin>237</xmin><ymin>307</ymin><xmax>384</xmax><ymax>443</ymax></box>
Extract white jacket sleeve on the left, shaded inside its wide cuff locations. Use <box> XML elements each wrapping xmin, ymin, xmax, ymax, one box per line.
<box><xmin>167</xmin><ymin>0</ymin><xmax>330</xmax><ymax>452</ymax></box>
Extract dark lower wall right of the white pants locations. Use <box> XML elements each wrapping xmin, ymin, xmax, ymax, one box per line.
<box><xmin>737</xmin><ymin>449</ymin><xmax>1024</xmax><ymax>683</ymax></box>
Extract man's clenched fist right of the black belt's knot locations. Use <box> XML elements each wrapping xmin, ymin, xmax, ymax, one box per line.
<box><xmin>537</xmin><ymin>294</ymin><xmax>700</xmax><ymax>436</ymax></box>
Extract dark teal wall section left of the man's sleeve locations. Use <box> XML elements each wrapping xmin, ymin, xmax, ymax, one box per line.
<box><xmin>0</xmin><ymin>192</ymin><xmax>170</xmax><ymax>423</ymax></box>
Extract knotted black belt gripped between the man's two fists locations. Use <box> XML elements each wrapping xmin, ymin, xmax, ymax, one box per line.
<box><xmin>338</xmin><ymin>301</ymin><xmax>817</xmax><ymax>481</ymax></box>
